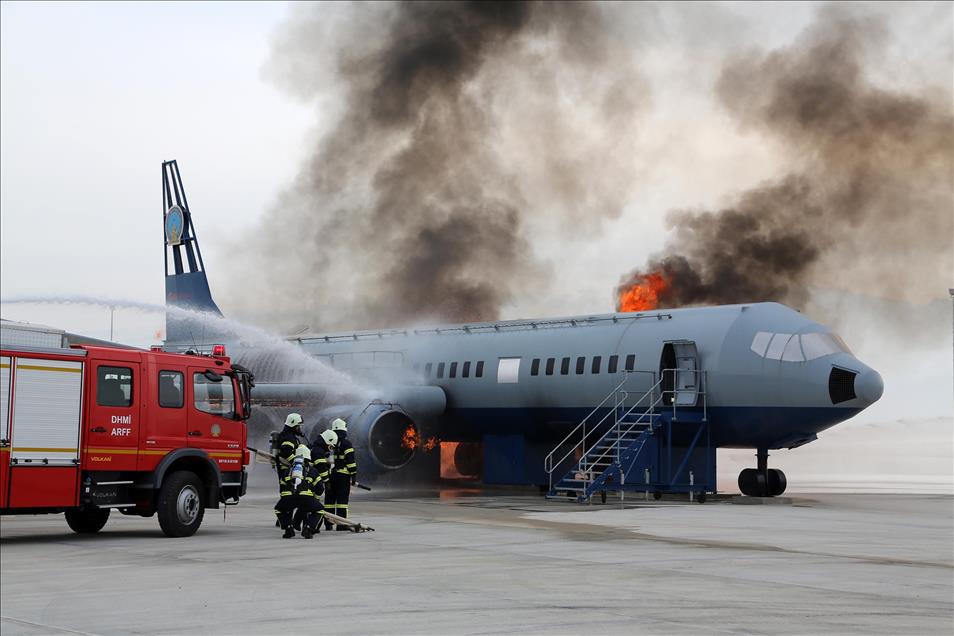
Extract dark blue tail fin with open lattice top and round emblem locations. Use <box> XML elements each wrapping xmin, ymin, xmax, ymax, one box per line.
<box><xmin>162</xmin><ymin>160</ymin><xmax>222</xmax><ymax>342</ymax></box>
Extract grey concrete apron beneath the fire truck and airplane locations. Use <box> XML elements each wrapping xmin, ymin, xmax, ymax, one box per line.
<box><xmin>0</xmin><ymin>490</ymin><xmax>954</xmax><ymax>636</ymax></box>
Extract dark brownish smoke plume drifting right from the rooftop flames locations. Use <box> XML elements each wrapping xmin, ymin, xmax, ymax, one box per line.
<box><xmin>617</xmin><ymin>6</ymin><xmax>954</xmax><ymax>307</ymax></box>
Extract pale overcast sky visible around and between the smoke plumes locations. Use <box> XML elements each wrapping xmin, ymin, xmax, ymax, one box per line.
<box><xmin>0</xmin><ymin>2</ymin><xmax>954</xmax><ymax>486</ymax></box>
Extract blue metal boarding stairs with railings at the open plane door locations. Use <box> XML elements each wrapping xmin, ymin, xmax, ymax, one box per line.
<box><xmin>544</xmin><ymin>368</ymin><xmax>716</xmax><ymax>503</ymax></box>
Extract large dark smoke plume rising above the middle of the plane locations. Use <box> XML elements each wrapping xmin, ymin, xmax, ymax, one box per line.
<box><xmin>243</xmin><ymin>2</ymin><xmax>647</xmax><ymax>329</ymax></box>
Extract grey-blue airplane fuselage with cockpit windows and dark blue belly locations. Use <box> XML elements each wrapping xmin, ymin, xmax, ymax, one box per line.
<box><xmin>284</xmin><ymin>303</ymin><xmax>883</xmax><ymax>448</ymax></box>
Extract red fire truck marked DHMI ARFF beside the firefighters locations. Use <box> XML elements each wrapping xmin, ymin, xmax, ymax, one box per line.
<box><xmin>0</xmin><ymin>322</ymin><xmax>254</xmax><ymax>537</ymax></box>
